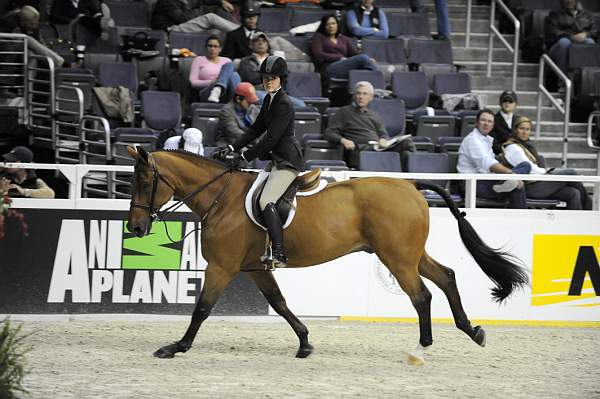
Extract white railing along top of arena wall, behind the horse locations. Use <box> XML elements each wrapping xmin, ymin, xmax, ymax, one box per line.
<box><xmin>0</xmin><ymin>163</ymin><xmax>600</xmax><ymax>212</ymax></box>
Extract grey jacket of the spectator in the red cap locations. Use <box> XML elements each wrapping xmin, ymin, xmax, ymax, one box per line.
<box><xmin>216</xmin><ymin>101</ymin><xmax>260</xmax><ymax>147</ymax></box>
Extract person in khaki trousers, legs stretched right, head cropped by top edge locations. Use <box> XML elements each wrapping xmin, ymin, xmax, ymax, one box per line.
<box><xmin>150</xmin><ymin>0</ymin><xmax>238</xmax><ymax>32</ymax></box>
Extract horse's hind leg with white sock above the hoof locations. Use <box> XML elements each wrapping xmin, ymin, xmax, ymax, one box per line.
<box><xmin>384</xmin><ymin>261</ymin><xmax>433</xmax><ymax>366</ymax></box>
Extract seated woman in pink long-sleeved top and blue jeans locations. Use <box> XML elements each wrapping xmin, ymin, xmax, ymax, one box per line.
<box><xmin>190</xmin><ymin>35</ymin><xmax>240</xmax><ymax>103</ymax></box>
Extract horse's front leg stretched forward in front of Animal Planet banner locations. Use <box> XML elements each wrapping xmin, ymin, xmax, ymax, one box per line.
<box><xmin>154</xmin><ymin>264</ymin><xmax>236</xmax><ymax>359</ymax></box>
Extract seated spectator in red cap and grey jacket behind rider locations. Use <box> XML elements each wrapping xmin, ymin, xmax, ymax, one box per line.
<box><xmin>217</xmin><ymin>82</ymin><xmax>260</xmax><ymax>147</ymax></box>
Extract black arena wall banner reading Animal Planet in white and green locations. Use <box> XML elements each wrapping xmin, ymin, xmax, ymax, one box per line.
<box><xmin>0</xmin><ymin>209</ymin><xmax>268</xmax><ymax>315</ymax></box>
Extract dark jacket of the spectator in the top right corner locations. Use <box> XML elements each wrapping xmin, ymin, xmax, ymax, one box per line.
<box><xmin>544</xmin><ymin>5</ymin><xmax>598</xmax><ymax>47</ymax></box>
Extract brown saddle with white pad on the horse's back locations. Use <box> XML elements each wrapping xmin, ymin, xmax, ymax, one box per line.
<box><xmin>246</xmin><ymin>168</ymin><xmax>327</xmax><ymax>230</ymax></box>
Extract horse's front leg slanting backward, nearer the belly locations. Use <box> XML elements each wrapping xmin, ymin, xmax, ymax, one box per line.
<box><xmin>249</xmin><ymin>272</ymin><xmax>313</xmax><ymax>358</ymax></box>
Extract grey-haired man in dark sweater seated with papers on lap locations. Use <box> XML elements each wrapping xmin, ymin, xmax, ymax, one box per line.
<box><xmin>324</xmin><ymin>81</ymin><xmax>415</xmax><ymax>169</ymax></box>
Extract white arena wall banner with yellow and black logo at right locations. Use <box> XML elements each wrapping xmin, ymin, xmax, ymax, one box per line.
<box><xmin>276</xmin><ymin>208</ymin><xmax>600</xmax><ymax>322</ymax></box>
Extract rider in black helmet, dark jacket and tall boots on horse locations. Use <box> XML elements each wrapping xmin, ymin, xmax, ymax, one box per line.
<box><xmin>217</xmin><ymin>55</ymin><xmax>304</xmax><ymax>267</ymax></box>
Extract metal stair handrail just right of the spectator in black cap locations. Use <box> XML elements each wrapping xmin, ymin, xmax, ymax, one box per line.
<box><xmin>535</xmin><ymin>54</ymin><xmax>573</xmax><ymax>166</ymax></box>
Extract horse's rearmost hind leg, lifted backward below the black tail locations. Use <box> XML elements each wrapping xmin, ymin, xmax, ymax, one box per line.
<box><xmin>419</xmin><ymin>252</ymin><xmax>485</xmax><ymax>346</ymax></box>
